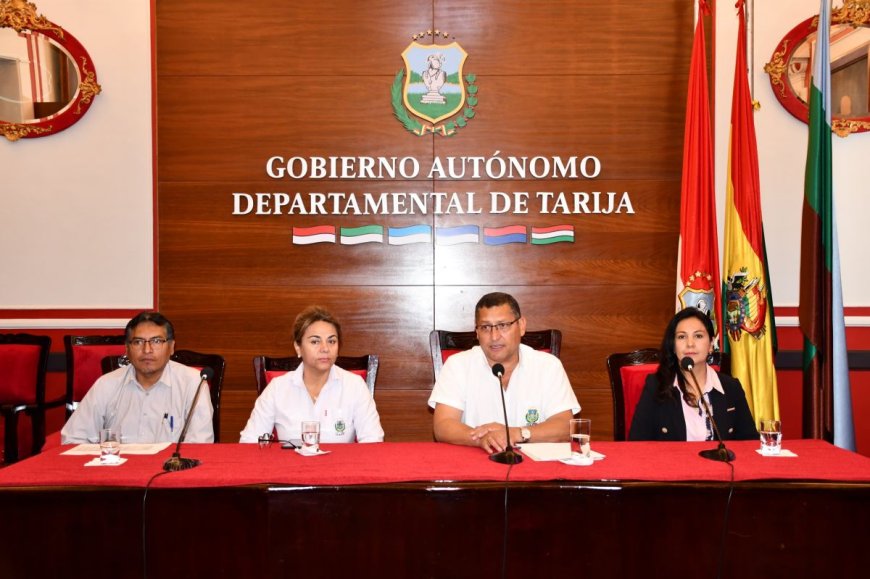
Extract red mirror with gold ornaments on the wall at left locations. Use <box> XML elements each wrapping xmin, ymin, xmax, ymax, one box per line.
<box><xmin>0</xmin><ymin>0</ymin><xmax>102</xmax><ymax>141</ymax></box>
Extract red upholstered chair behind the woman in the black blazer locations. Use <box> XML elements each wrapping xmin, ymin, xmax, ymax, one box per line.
<box><xmin>607</xmin><ymin>348</ymin><xmax>731</xmax><ymax>440</ymax></box>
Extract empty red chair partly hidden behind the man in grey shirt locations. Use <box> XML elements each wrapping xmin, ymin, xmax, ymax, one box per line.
<box><xmin>63</xmin><ymin>334</ymin><xmax>126</xmax><ymax>418</ymax></box>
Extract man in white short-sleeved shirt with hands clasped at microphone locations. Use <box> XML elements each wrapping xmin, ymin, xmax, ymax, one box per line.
<box><xmin>429</xmin><ymin>292</ymin><xmax>580</xmax><ymax>454</ymax></box>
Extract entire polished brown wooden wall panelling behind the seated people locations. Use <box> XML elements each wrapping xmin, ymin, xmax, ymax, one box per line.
<box><xmin>156</xmin><ymin>0</ymin><xmax>692</xmax><ymax>440</ymax></box>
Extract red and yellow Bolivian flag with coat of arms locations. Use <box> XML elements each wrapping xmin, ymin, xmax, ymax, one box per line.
<box><xmin>722</xmin><ymin>0</ymin><xmax>779</xmax><ymax>422</ymax></box>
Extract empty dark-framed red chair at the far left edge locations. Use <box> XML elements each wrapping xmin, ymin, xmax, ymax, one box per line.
<box><xmin>0</xmin><ymin>334</ymin><xmax>51</xmax><ymax>463</ymax></box>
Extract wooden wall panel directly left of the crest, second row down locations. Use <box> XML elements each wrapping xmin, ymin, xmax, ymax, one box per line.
<box><xmin>157</xmin><ymin>76</ymin><xmax>432</xmax><ymax>181</ymax></box>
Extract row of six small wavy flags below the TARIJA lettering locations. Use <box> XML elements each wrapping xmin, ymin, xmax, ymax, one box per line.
<box><xmin>293</xmin><ymin>225</ymin><xmax>574</xmax><ymax>245</ymax></box>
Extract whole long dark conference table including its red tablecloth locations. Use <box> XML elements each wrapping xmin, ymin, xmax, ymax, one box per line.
<box><xmin>0</xmin><ymin>440</ymin><xmax>870</xmax><ymax>579</ymax></box>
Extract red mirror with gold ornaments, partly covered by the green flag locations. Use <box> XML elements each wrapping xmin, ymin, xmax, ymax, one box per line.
<box><xmin>764</xmin><ymin>0</ymin><xmax>870</xmax><ymax>137</ymax></box>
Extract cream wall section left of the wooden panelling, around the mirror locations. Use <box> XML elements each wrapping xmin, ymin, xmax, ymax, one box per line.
<box><xmin>0</xmin><ymin>0</ymin><xmax>154</xmax><ymax>309</ymax></box>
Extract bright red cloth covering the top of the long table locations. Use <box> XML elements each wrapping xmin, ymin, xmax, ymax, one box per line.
<box><xmin>0</xmin><ymin>440</ymin><xmax>870</xmax><ymax>487</ymax></box>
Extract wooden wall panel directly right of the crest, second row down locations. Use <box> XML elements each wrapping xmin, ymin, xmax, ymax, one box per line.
<box><xmin>435</xmin><ymin>73</ymin><xmax>687</xmax><ymax>180</ymax></box>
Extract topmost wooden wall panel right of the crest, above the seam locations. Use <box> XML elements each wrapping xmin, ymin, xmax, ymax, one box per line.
<box><xmin>435</xmin><ymin>0</ymin><xmax>693</xmax><ymax>75</ymax></box>
